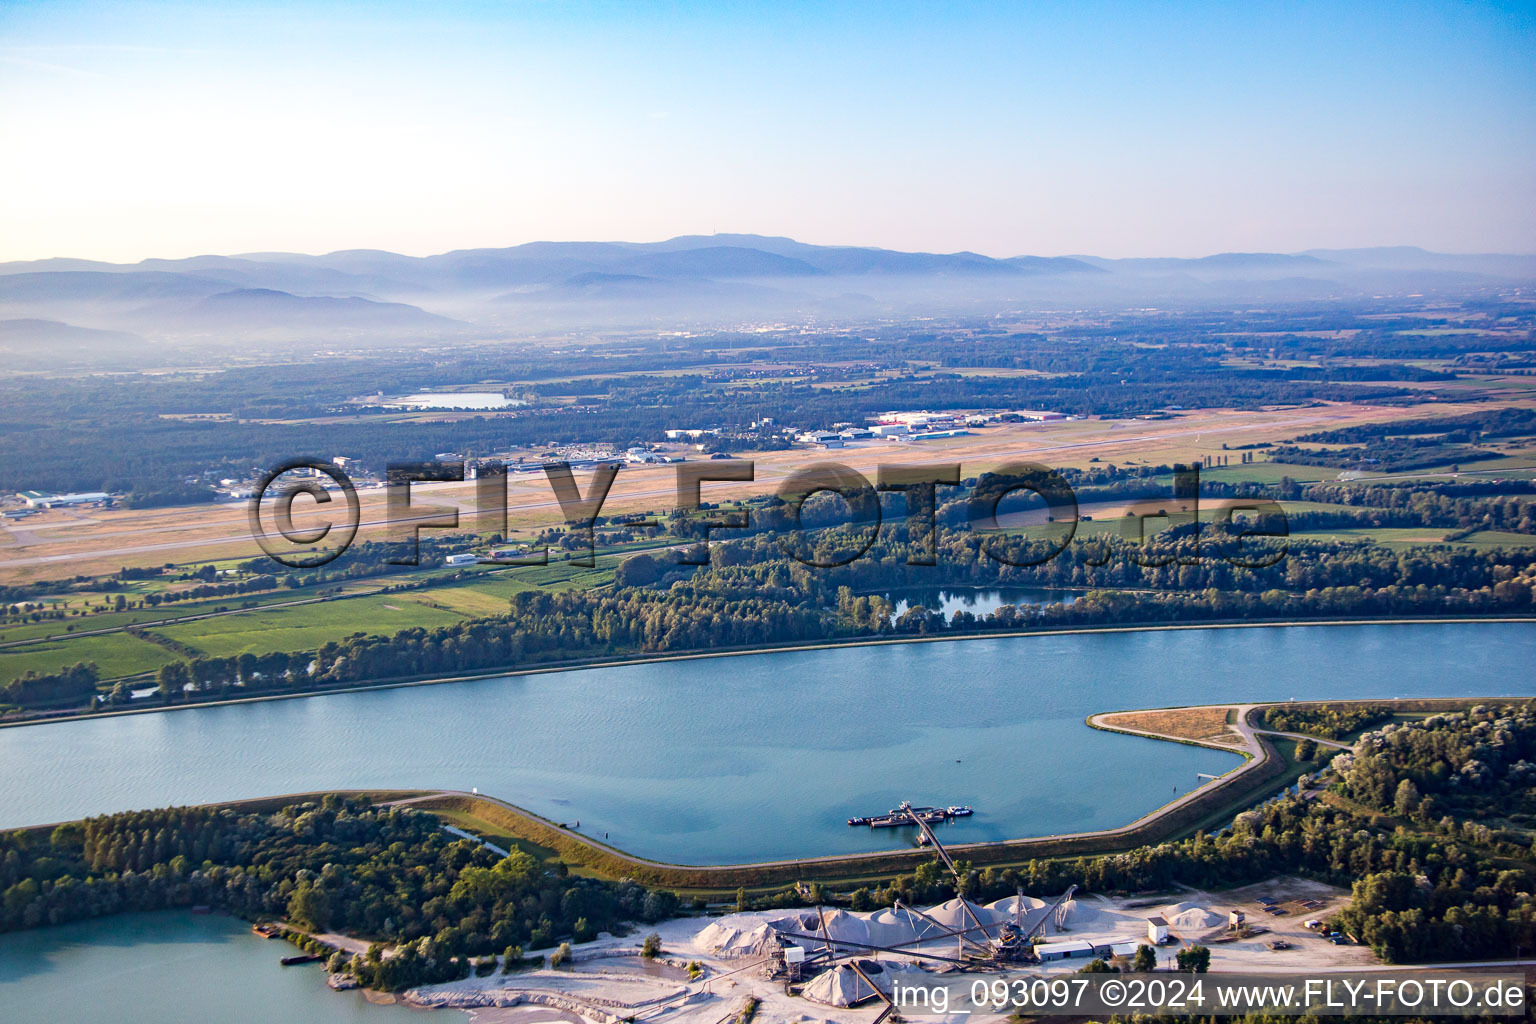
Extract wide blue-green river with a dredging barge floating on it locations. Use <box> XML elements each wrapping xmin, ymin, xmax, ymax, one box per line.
<box><xmin>0</xmin><ymin>622</ymin><xmax>1536</xmax><ymax>863</ymax></box>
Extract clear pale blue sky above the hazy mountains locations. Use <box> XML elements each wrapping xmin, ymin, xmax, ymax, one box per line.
<box><xmin>0</xmin><ymin>0</ymin><xmax>1536</xmax><ymax>261</ymax></box>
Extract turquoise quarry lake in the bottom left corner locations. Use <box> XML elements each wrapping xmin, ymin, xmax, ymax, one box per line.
<box><xmin>0</xmin><ymin>912</ymin><xmax>468</xmax><ymax>1024</ymax></box>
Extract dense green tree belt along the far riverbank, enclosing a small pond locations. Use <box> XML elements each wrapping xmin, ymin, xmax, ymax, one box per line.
<box><xmin>17</xmin><ymin>527</ymin><xmax>1536</xmax><ymax>703</ymax></box>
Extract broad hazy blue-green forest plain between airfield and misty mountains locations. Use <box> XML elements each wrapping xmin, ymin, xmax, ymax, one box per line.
<box><xmin>0</xmin><ymin>302</ymin><xmax>1499</xmax><ymax>494</ymax></box>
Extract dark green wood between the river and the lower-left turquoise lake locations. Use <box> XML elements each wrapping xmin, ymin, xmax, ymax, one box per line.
<box><xmin>0</xmin><ymin>797</ymin><xmax>677</xmax><ymax>990</ymax></box>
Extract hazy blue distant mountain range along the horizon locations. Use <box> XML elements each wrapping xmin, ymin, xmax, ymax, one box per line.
<box><xmin>0</xmin><ymin>235</ymin><xmax>1536</xmax><ymax>352</ymax></box>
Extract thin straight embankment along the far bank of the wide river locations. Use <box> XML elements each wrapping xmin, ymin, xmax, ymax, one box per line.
<box><xmin>0</xmin><ymin>614</ymin><xmax>1536</xmax><ymax>729</ymax></box>
